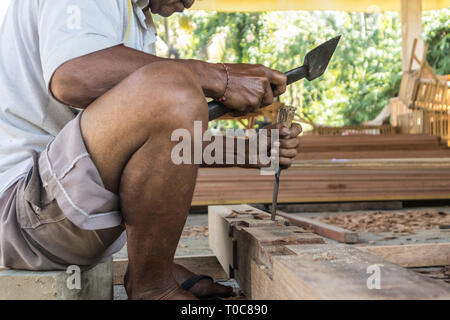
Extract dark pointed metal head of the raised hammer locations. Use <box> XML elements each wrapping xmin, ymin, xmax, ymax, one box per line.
<box><xmin>304</xmin><ymin>36</ymin><xmax>341</xmax><ymax>81</ymax></box>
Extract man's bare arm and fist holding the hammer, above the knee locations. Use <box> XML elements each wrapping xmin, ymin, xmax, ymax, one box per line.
<box><xmin>50</xmin><ymin>45</ymin><xmax>286</xmax><ymax>112</ymax></box>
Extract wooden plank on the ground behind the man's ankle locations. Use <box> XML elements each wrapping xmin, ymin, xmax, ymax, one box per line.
<box><xmin>114</xmin><ymin>255</ymin><xmax>229</xmax><ymax>285</ymax></box>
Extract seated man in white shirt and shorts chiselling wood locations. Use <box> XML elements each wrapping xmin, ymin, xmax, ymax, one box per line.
<box><xmin>0</xmin><ymin>0</ymin><xmax>301</xmax><ymax>299</ymax></box>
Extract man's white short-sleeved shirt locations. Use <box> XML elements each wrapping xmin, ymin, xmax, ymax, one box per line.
<box><xmin>0</xmin><ymin>0</ymin><xmax>156</xmax><ymax>194</ymax></box>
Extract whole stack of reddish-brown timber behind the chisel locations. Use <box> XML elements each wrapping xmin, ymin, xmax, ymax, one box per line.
<box><xmin>193</xmin><ymin>135</ymin><xmax>450</xmax><ymax>205</ymax></box>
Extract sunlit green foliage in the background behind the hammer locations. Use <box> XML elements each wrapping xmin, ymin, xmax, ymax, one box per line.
<box><xmin>157</xmin><ymin>9</ymin><xmax>450</xmax><ymax>127</ymax></box>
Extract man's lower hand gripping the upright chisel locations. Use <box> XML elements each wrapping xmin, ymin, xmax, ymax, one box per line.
<box><xmin>264</xmin><ymin>123</ymin><xmax>303</xmax><ymax>170</ymax></box>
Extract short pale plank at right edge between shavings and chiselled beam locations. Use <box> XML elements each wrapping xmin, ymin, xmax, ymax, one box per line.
<box><xmin>358</xmin><ymin>243</ymin><xmax>450</xmax><ymax>267</ymax></box>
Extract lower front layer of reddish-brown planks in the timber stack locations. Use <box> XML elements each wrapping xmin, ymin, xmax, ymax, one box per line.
<box><xmin>193</xmin><ymin>159</ymin><xmax>450</xmax><ymax>205</ymax></box>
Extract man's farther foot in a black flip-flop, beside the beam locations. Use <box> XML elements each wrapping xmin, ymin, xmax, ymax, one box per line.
<box><xmin>173</xmin><ymin>263</ymin><xmax>233</xmax><ymax>299</ymax></box>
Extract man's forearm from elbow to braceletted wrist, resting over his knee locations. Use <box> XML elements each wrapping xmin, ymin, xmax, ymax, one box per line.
<box><xmin>50</xmin><ymin>45</ymin><xmax>224</xmax><ymax>108</ymax></box>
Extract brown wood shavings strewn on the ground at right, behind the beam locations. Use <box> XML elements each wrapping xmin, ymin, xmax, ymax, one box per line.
<box><xmin>319</xmin><ymin>209</ymin><xmax>450</xmax><ymax>234</ymax></box>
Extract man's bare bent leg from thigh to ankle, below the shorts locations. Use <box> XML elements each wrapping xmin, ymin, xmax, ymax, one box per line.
<box><xmin>81</xmin><ymin>62</ymin><xmax>208</xmax><ymax>299</ymax></box>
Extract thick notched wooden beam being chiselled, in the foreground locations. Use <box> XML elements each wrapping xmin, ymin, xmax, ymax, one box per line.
<box><xmin>209</xmin><ymin>206</ymin><xmax>450</xmax><ymax>300</ymax></box>
